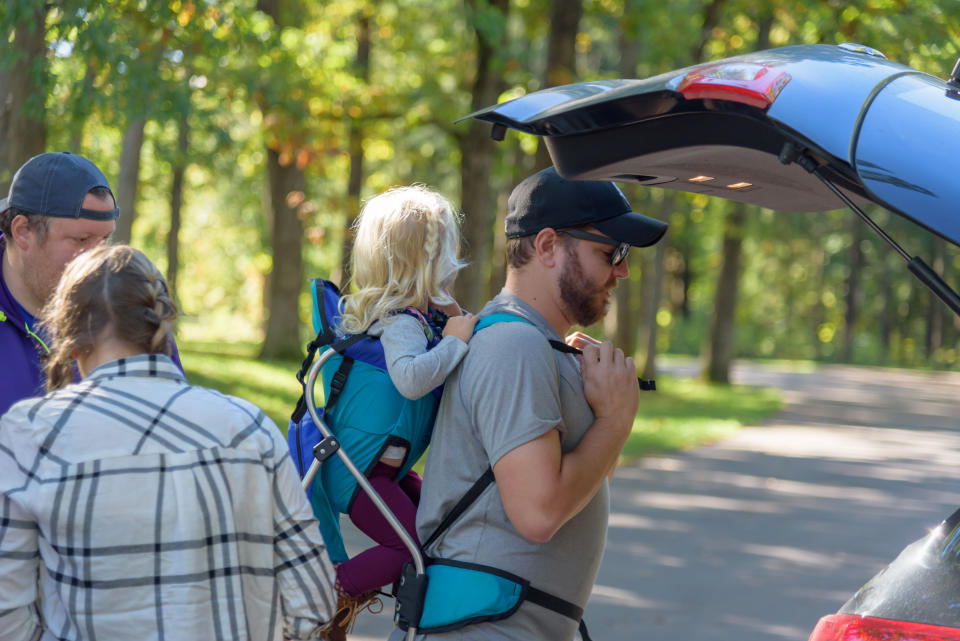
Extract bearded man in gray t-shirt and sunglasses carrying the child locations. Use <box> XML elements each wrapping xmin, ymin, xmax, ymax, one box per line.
<box><xmin>394</xmin><ymin>168</ymin><xmax>667</xmax><ymax>641</ymax></box>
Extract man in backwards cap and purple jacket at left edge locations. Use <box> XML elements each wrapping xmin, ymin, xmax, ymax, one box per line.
<box><xmin>0</xmin><ymin>152</ymin><xmax>119</xmax><ymax>414</ymax></box>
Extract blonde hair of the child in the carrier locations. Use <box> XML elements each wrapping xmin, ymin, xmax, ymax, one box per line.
<box><xmin>341</xmin><ymin>185</ymin><xmax>465</xmax><ymax>334</ymax></box>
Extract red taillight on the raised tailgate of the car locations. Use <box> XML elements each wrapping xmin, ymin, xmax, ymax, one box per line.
<box><xmin>677</xmin><ymin>62</ymin><xmax>790</xmax><ymax>109</ymax></box>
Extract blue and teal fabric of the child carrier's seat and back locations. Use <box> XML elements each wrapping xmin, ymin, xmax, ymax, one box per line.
<box><xmin>287</xmin><ymin>279</ymin><xmax>438</xmax><ymax>563</ymax></box>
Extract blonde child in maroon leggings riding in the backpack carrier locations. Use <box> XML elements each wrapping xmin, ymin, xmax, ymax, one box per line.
<box><xmin>327</xmin><ymin>185</ymin><xmax>477</xmax><ymax>639</ymax></box>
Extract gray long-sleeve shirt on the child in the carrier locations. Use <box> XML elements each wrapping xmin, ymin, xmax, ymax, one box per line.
<box><xmin>368</xmin><ymin>314</ymin><xmax>468</xmax><ymax>400</ymax></box>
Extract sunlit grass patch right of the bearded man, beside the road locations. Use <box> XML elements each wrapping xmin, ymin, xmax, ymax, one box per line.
<box><xmin>623</xmin><ymin>375</ymin><xmax>783</xmax><ymax>460</ymax></box>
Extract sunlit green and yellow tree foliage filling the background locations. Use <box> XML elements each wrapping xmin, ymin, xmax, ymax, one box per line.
<box><xmin>13</xmin><ymin>0</ymin><xmax>960</xmax><ymax>366</ymax></box>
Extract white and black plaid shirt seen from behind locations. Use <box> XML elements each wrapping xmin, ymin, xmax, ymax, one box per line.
<box><xmin>0</xmin><ymin>355</ymin><xmax>336</xmax><ymax>641</ymax></box>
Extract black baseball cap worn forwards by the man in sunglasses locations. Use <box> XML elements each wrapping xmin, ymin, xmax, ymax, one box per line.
<box><xmin>505</xmin><ymin>167</ymin><xmax>667</xmax><ymax>247</ymax></box>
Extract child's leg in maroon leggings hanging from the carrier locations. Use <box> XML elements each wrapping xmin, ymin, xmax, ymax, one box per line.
<box><xmin>337</xmin><ymin>463</ymin><xmax>419</xmax><ymax>597</ymax></box>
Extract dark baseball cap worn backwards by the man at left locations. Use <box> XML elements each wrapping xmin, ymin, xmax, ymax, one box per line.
<box><xmin>0</xmin><ymin>151</ymin><xmax>120</xmax><ymax>220</ymax></box>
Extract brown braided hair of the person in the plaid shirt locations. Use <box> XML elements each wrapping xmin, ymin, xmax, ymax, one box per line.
<box><xmin>40</xmin><ymin>245</ymin><xmax>177</xmax><ymax>391</ymax></box>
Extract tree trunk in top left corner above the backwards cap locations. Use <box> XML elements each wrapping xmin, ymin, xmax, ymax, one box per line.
<box><xmin>0</xmin><ymin>2</ymin><xmax>52</xmax><ymax>191</ymax></box>
